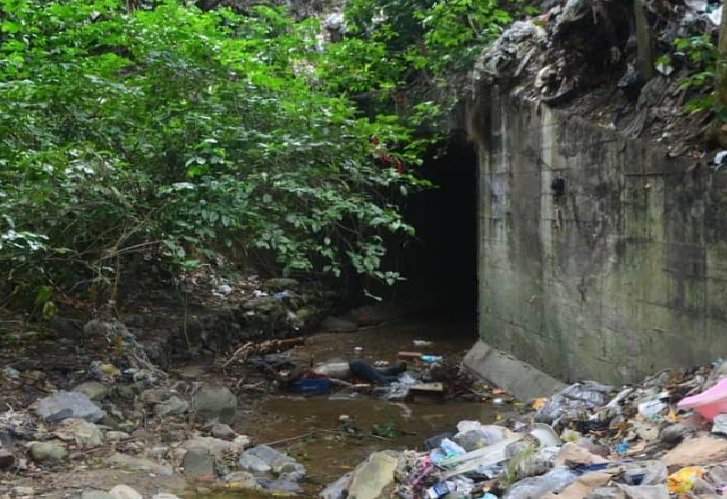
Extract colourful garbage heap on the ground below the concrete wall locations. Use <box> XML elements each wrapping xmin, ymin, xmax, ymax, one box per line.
<box><xmin>321</xmin><ymin>363</ymin><xmax>727</xmax><ymax>499</ymax></box>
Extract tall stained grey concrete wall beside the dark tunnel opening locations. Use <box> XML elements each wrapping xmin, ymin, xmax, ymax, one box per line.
<box><xmin>475</xmin><ymin>89</ymin><xmax>727</xmax><ymax>382</ymax></box>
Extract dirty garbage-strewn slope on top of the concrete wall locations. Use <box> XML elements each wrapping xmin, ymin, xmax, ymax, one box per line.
<box><xmin>473</xmin><ymin>0</ymin><xmax>722</xmax><ymax>145</ymax></box>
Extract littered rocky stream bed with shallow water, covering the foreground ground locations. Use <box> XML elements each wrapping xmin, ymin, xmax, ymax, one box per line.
<box><xmin>5</xmin><ymin>281</ymin><xmax>727</xmax><ymax>499</ymax></box>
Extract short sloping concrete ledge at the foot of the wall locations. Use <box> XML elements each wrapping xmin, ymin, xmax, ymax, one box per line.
<box><xmin>464</xmin><ymin>340</ymin><xmax>567</xmax><ymax>400</ymax></box>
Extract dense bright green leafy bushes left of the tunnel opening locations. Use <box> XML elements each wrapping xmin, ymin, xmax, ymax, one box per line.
<box><xmin>0</xmin><ymin>0</ymin><xmax>524</xmax><ymax>315</ymax></box>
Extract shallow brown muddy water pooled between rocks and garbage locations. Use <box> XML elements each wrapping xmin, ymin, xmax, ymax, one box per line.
<box><xmin>228</xmin><ymin>322</ymin><xmax>508</xmax><ymax>497</ymax></box>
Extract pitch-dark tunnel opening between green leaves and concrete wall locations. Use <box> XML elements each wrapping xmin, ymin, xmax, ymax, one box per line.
<box><xmin>397</xmin><ymin>136</ymin><xmax>478</xmax><ymax>328</ymax></box>
